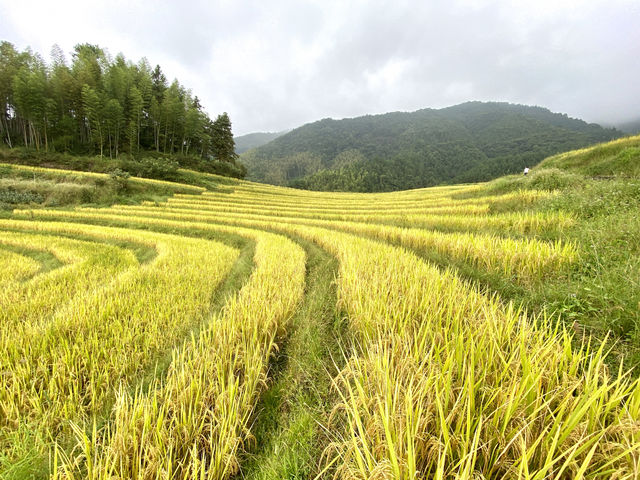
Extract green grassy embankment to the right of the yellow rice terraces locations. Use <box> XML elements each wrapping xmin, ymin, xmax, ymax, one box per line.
<box><xmin>465</xmin><ymin>136</ymin><xmax>640</xmax><ymax>366</ymax></box>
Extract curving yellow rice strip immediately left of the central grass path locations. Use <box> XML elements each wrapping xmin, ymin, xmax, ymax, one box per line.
<box><xmin>53</xmin><ymin>229</ymin><xmax>305</xmax><ymax>479</ymax></box>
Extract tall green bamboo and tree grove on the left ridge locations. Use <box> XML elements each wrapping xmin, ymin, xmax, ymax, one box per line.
<box><xmin>0</xmin><ymin>42</ymin><xmax>237</xmax><ymax>169</ymax></box>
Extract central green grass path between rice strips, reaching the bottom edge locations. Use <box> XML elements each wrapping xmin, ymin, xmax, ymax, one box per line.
<box><xmin>242</xmin><ymin>237</ymin><xmax>346</xmax><ymax>480</ymax></box>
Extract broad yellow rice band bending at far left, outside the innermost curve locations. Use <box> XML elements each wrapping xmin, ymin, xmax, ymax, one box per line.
<box><xmin>0</xmin><ymin>220</ymin><xmax>237</xmax><ymax>472</ymax></box>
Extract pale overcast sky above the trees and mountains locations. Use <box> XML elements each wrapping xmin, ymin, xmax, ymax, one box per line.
<box><xmin>0</xmin><ymin>0</ymin><xmax>640</xmax><ymax>135</ymax></box>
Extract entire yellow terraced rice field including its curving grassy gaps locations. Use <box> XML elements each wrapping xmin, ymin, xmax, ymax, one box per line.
<box><xmin>0</xmin><ymin>177</ymin><xmax>640</xmax><ymax>480</ymax></box>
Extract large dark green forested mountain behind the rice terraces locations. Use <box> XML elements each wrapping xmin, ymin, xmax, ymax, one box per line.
<box><xmin>241</xmin><ymin>102</ymin><xmax>622</xmax><ymax>192</ymax></box>
